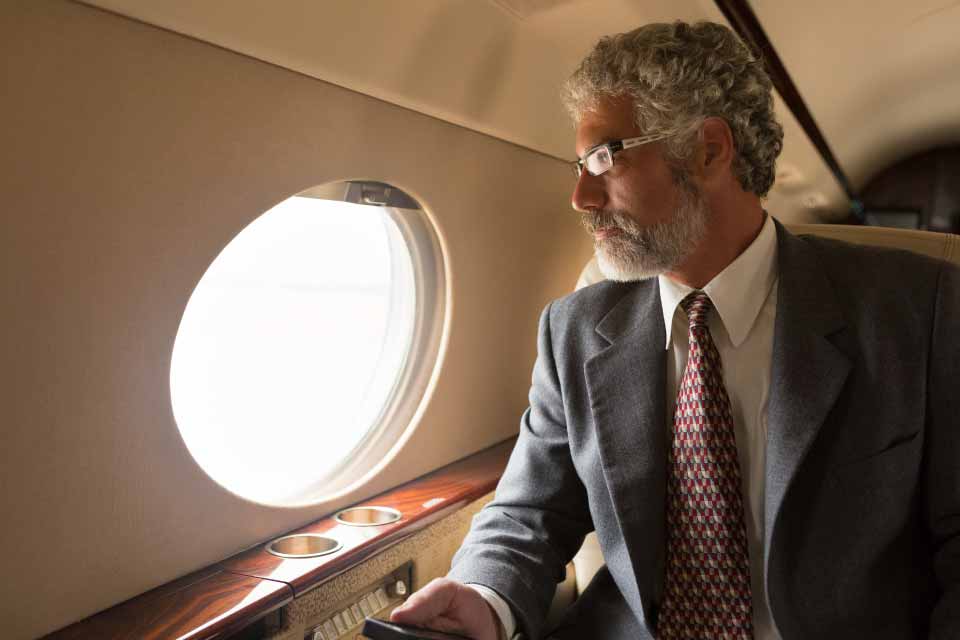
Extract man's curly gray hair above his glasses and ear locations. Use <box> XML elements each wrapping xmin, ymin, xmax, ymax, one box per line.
<box><xmin>563</xmin><ymin>21</ymin><xmax>783</xmax><ymax>197</ymax></box>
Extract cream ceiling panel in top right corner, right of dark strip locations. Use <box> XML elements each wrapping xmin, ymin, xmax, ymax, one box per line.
<box><xmin>751</xmin><ymin>0</ymin><xmax>960</xmax><ymax>189</ymax></box>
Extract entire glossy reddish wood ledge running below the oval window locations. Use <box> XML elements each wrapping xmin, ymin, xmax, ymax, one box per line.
<box><xmin>45</xmin><ymin>438</ymin><xmax>515</xmax><ymax>640</ymax></box>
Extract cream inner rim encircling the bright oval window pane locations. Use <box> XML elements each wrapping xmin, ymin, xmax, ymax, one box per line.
<box><xmin>170</xmin><ymin>182</ymin><xmax>450</xmax><ymax>508</ymax></box>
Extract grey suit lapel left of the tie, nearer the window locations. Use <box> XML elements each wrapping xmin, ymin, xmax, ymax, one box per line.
<box><xmin>584</xmin><ymin>279</ymin><xmax>667</xmax><ymax>632</ymax></box>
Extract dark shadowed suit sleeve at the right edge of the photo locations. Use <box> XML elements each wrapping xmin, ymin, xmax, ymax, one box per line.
<box><xmin>924</xmin><ymin>265</ymin><xmax>960</xmax><ymax>639</ymax></box>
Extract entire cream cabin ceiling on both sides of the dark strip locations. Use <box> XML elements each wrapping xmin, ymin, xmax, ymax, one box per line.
<box><xmin>79</xmin><ymin>0</ymin><xmax>960</xmax><ymax>222</ymax></box>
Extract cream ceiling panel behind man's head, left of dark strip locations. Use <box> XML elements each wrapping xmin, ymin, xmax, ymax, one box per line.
<box><xmin>75</xmin><ymin>0</ymin><xmax>846</xmax><ymax>222</ymax></box>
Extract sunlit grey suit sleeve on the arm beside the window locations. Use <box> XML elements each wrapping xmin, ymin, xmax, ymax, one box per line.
<box><xmin>449</xmin><ymin>306</ymin><xmax>593</xmax><ymax>638</ymax></box>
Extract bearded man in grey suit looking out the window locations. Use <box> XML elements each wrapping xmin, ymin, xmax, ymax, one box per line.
<box><xmin>394</xmin><ymin>23</ymin><xmax>960</xmax><ymax>640</ymax></box>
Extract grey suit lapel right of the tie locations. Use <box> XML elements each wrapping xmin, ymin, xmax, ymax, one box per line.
<box><xmin>764</xmin><ymin>223</ymin><xmax>851</xmax><ymax>585</ymax></box>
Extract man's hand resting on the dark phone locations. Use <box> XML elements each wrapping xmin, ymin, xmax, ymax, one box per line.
<box><xmin>390</xmin><ymin>578</ymin><xmax>500</xmax><ymax>640</ymax></box>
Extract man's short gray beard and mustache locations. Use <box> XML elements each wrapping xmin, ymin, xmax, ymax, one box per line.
<box><xmin>583</xmin><ymin>183</ymin><xmax>708</xmax><ymax>282</ymax></box>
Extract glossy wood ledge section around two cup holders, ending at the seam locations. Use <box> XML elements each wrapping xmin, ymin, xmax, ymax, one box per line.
<box><xmin>221</xmin><ymin>438</ymin><xmax>515</xmax><ymax>596</ymax></box>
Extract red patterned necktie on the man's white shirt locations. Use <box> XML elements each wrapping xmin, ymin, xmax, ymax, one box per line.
<box><xmin>657</xmin><ymin>291</ymin><xmax>753</xmax><ymax>640</ymax></box>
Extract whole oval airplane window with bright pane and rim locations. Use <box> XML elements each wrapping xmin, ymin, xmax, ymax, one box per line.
<box><xmin>170</xmin><ymin>182</ymin><xmax>445</xmax><ymax>506</ymax></box>
